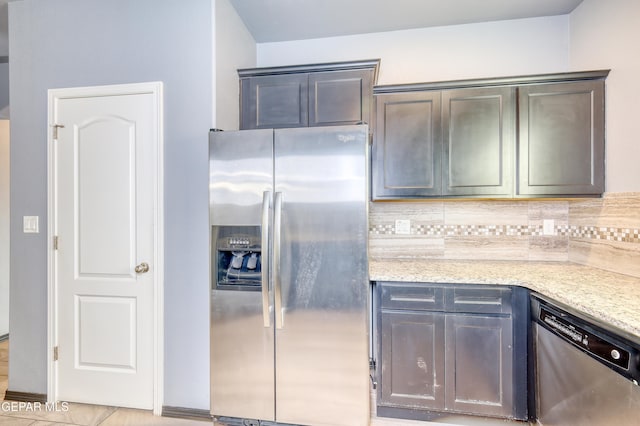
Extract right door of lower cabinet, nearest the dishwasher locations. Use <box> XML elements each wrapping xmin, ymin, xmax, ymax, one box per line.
<box><xmin>445</xmin><ymin>314</ymin><xmax>513</xmax><ymax>417</ymax></box>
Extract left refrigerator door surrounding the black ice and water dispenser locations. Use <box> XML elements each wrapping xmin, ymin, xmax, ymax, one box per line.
<box><xmin>209</xmin><ymin>130</ymin><xmax>275</xmax><ymax>421</ymax></box>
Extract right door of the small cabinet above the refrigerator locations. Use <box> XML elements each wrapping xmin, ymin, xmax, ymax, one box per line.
<box><xmin>309</xmin><ymin>70</ymin><xmax>373</xmax><ymax>126</ymax></box>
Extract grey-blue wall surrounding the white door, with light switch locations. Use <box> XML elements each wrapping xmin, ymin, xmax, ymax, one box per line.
<box><xmin>9</xmin><ymin>0</ymin><xmax>215</xmax><ymax>410</ymax></box>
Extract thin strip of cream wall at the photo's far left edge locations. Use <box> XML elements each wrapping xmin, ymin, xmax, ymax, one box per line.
<box><xmin>0</xmin><ymin>120</ymin><xmax>9</xmax><ymax>336</ymax></box>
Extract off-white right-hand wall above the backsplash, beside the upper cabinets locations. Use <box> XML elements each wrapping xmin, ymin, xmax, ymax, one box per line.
<box><xmin>569</xmin><ymin>0</ymin><xmax>640</xmax><ymax>192</ymax></box>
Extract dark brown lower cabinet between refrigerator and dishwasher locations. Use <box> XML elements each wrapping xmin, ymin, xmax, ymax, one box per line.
<box><xmin>377</xmin><ymin>283</ymin><xmax>528</xmax><ymax>420</ymax></box>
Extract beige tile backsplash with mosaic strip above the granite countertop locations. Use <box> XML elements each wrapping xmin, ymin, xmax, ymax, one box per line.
<box><xmin>369</xmin><ymin>193</ymin><xmax>640</xmax><ymax>276</ymax></box>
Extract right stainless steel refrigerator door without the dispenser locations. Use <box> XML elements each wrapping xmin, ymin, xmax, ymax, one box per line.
<box><xmin>273</xmin><ymin>126</ymin><xmax>369</xmax><ymax>426</ymax></box>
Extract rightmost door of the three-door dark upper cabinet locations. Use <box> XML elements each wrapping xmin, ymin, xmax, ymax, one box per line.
<box><xmin>518</xmin><ymin>80</ymin><xmax>604</xmax><ymax>195</ymax></box>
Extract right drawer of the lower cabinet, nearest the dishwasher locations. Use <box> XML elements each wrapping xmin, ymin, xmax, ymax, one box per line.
<box><xmin>445</xmin><ymin>286</ymin><xmax>511</xmax><ymax>314</ymax></box>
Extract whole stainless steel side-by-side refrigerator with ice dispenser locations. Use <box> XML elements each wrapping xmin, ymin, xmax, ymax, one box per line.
<box><xmin>209</xmin><ymin>125</ymin><xmax>369</xmax><ymax>426</ymax></box>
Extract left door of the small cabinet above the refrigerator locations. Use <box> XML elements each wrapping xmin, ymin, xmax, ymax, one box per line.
<box><xmin>240</xmin><ymin>74</ymin><xmax>309</xmax><ymax>130</ymax></box>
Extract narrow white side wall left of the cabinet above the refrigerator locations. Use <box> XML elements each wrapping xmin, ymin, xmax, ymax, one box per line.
<box><xmin>213</xmin><ymin>0</ymin><xmax>256</xmax><ymax>130</ymax></box>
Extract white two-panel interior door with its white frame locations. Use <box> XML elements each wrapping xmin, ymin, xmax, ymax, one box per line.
<box><xmin>51</xmin><ymin>84</ymin><xmax>161</xmax><ymax>409</ymax></box>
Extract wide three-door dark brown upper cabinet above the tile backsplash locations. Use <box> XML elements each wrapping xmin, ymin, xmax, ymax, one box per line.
<box><xmin>372</xmin><ymin>70</ymin><xmax>608</xmax><ymax>200</ymax></box>
